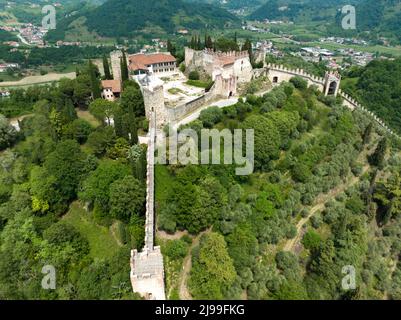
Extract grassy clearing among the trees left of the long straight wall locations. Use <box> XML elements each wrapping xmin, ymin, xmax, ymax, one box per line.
<box><xmin>63</xmin><ymin>202</ymin><xmax>119</xmax><ymax>259</ymax></box>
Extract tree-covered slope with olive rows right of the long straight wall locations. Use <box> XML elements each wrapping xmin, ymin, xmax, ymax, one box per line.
<box><xmin>156</xmin><ymin>78</ymin><xmax>401</xmax><ymax>299</ymax></box>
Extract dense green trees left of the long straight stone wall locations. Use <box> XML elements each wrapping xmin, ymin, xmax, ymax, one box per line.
<box><xmin>0</xmin><ymin>62</ymin><xmax>146</xmax><ymax>299</ymax></box>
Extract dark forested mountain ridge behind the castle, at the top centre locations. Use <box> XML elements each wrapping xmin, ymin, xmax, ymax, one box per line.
<box><xmin>45</xmin><ymin>0</ymin><xmax>239</xmax><ymax>38</ymax></box>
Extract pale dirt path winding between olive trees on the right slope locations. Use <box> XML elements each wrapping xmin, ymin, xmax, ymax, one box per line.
<box><xmin>283</xmin><ymin>165</ymin><xmax>369</xmax><ymax>252</ymax></box>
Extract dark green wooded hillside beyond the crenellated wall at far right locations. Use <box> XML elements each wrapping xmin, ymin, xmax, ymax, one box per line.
<box><xmin>343</xmin><ymin>58</ymin><xmax>401</xmax><ymax>133</ymax></box>
